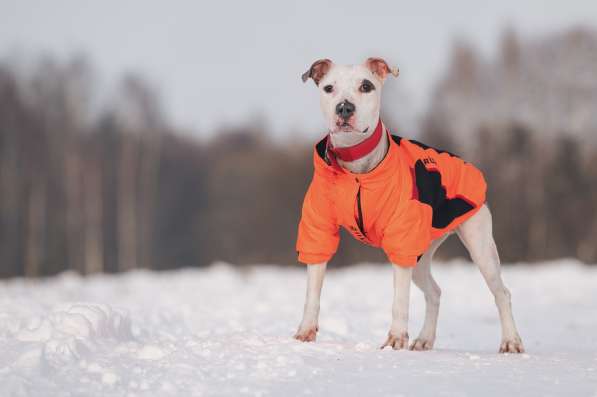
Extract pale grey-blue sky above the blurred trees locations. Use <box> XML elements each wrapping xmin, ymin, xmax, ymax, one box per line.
<box><xmin>0</xmin><ymin>0</ymin><xmax>597</xmax><ymax>136</ymax></box>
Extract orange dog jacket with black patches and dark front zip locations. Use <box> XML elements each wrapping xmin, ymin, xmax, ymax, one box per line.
<box><xmin>296</xmin><ymin>122</ymin><xmax>487</xmax><ymax>266</ymax></box>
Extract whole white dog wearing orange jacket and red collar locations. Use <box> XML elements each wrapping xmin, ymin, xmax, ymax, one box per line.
<box><xmin>294</xmin><ymin>58</ymin><xmax>524</xmax><ymax>353</ymax></box>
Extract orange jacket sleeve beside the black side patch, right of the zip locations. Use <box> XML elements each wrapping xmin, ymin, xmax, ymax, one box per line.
<box><xmin>381</xmin><ymin>200</ymin><xmax>433</xmax><ymax>267</ymax></box>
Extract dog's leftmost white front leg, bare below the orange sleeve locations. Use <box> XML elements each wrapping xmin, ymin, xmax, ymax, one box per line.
<box><xmin>294</xmin><ymin>262</ymin><xmax>327</xmax><ymax>342</ymax></box>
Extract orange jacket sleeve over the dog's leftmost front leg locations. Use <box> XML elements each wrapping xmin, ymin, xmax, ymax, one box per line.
<box><xmin>296</xmin><ymin>174</ymin><xmax>340</xmax><ymax>264</ymax></box>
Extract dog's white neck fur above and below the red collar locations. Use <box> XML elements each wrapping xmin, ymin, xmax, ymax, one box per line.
<box><xmin>330</xmin><ymin>122</ymin><xmax>389</xmax><ymax>174</ymax></box>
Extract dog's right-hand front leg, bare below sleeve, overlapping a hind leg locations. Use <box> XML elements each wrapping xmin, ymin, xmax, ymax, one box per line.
<box><xmin>381</xmin><ymin>265</ymin><xmax>413</xmax><ymax>350</ymax></box>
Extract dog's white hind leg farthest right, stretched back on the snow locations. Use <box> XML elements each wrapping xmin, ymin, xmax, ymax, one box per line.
<box><xmin>457</xmin><ymin>205</ymin><xmax>524</xmax><ymax>353</ymax></box>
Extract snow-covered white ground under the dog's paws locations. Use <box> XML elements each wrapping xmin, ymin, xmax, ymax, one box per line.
<box><xmin>0</xmin><ymin>261</ymin><xmax>597</xmax><ymax>397</ymax></box>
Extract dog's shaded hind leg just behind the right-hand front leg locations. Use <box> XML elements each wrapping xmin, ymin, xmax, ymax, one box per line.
<box><xmin>409</xmin><ymin>234</ymin><xmax>448</xmax><ymax>350</ymax></box>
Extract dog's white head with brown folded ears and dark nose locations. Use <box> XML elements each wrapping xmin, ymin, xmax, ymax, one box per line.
<box><xmin>302</xmin><ymin>58</ymin><xmax>398</xmax><ymax>139</ymax></box>
